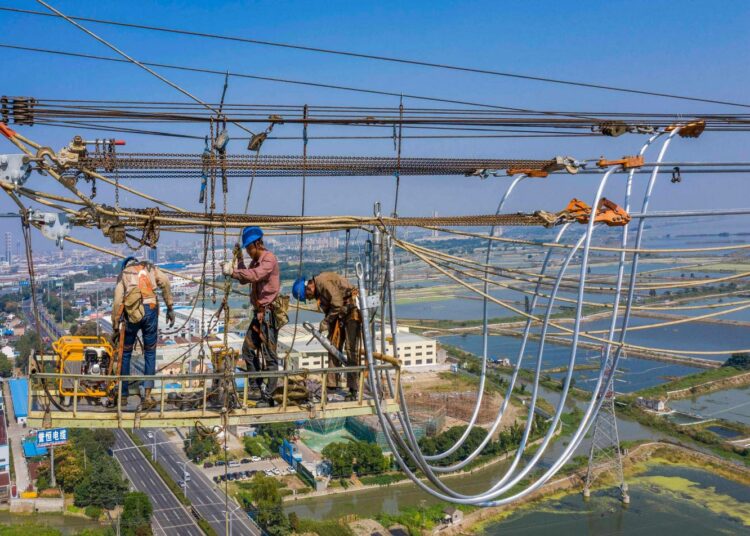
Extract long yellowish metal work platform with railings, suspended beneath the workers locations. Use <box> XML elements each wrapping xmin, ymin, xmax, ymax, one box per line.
<box><xmin>28</xmin><ymin>362</ymin><xmax>400</xmax><ymax>428</ymax></box>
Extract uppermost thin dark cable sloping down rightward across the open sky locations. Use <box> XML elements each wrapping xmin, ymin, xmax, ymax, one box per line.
<box><xmin>5</xmin><ymin>7</ymin><xmax>750</xmax><ymax>108</ymax></box>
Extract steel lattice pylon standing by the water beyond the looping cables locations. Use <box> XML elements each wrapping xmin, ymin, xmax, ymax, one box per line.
<box><xmin>583</xmin><ymin>349</ymin><xmax>630</xmax><ymax>504</ymax></box>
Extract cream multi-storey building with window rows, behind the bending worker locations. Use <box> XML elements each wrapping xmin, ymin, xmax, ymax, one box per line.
<box><xmin>278</xmin><ymin>324</ymin><xmax>438</xmax><ymax>371</ymax></box>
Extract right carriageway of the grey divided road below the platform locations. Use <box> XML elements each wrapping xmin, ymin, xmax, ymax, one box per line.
<box><xmin>135</xmin><ymin>429</ymin><xmax>261</xmax><ymax>536</ymax></box>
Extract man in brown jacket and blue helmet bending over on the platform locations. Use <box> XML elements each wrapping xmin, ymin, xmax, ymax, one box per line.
<box><xmin>292</xmin><ymin>272</ymin><xmax>362</xmax><ymax>399</ymax></box>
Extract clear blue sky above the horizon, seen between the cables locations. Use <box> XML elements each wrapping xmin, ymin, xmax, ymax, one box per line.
<box><xmin>0</xmin><ymin>0</ymin><xmax>750</xmax><ymax>251</ymax></box>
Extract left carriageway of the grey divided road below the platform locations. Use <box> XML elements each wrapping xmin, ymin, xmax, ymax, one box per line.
<box><xmin>113</xmin><ymin>430</ymin><xmax>203</xmax><ymax>536</ymax></box>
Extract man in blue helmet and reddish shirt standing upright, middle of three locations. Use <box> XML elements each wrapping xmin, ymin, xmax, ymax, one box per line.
<box><xmin>221</xmin><ymin>226</ymin><xmax>289</xmax><ymax>406</ymax></box>
